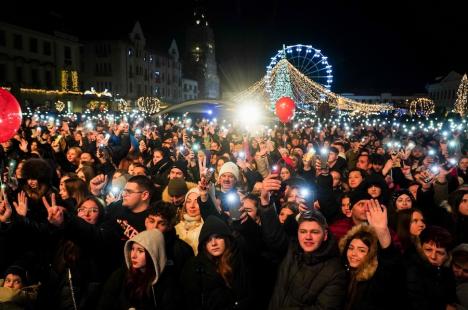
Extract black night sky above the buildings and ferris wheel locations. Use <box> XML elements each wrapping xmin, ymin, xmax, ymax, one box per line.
<box><xmin>0</xmin><ymin>0</ymin><xmax>468</xmax><ymax>95</ymax></box>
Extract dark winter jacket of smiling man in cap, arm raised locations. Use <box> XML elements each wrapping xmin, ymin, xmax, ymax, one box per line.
<box><xmin>261</xmin><ymin>207</ymin><xmax>346</xmax><ymax>310</ymax></box>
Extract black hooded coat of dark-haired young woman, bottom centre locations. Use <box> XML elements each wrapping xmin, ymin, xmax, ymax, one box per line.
<box><xmin>181</xmin><ymin>216</ymin><xmax>252</xmax><ymax>310</ymax></box>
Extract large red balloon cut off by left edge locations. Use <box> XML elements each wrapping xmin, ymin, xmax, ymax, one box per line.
<box><xmin>0</xmin><ymin>87</ymin><xmax>22</xmax><ymax>143</ymax></box>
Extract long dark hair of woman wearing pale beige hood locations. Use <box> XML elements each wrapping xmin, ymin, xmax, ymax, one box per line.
<box><xmin>125</xmin><ymin>242</ymin><xmax>156</xmax><ymax>302</ymax></box>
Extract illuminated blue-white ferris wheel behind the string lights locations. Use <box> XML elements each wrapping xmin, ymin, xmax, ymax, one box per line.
<box><xmin>266</xmin><ymin>44</ymin><xmax>333</xmax><ymax>91</ymax></box>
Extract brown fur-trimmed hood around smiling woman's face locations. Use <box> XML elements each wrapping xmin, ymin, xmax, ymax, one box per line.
<box><xmin>339</xmin><ymin>224</ymin><xmax>379</xmax><ymax>281</ymax></box>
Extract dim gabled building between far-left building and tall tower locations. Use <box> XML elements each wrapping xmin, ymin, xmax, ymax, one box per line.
<box><xmin>83</xmin><ymin>22</ymin><xmax>182</xmax><ymax>103</ymax></box>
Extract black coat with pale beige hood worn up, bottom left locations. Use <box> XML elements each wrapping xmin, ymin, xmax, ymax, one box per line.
<box><xmin>98</xmin><ymin>229</ymin><xmax>180</xmax><ymax>310</ymax></box>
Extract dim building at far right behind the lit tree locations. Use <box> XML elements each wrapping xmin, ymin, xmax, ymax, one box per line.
<box><xmin>426</xmin><ymin>71</ymin><xmax>462</xmax><ymax>110</ymax></box>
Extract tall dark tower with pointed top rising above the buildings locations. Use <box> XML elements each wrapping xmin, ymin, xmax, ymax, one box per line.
<box><xmin>184</xmin><ymin>7</ymin><xmax>220</xmax><ymax>99</ymax></box>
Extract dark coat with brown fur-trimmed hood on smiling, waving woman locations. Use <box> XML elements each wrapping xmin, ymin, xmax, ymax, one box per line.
<box><xmin>339</xmin><ymin>225</ymin><xmax>404</xmax><ymax>310</ymax></box>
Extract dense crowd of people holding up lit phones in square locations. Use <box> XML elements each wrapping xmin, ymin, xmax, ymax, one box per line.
<box><xmin>0</xmin><ymin>111</ymin><xmax>468</xmax><ymax>310</ymax></box>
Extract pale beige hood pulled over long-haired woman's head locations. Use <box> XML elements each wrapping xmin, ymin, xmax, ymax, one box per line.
<box><xmin>124</xmin><ymin>229</ymin><xmax>167</xmax><ymax>285</ymax></box>
